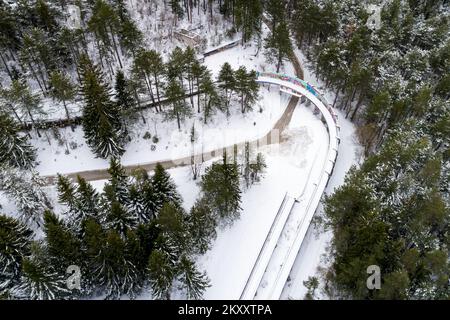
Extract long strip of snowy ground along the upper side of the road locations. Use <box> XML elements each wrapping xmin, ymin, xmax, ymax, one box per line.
<box><xmin>32</xmin><ymin>88</ymin><xmax>289</xmax><ymax>176</ymax></box>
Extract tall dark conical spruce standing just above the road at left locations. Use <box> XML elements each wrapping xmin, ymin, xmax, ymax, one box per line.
<box><xmin>81</xmin><ymin>56</ymin><xmax>124</xmax><ymax>158</ymax></box>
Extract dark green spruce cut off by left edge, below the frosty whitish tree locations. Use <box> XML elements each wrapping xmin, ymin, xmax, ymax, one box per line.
<box><xmin>0</xmin><ymin>215</ymin><xmax>33</xmax><ymax>297</ymax></box>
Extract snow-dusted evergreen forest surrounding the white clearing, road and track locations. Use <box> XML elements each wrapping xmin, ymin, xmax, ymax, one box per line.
<box><xmin>0</xmin><ymin>0</ymin><xmax>450</xmax><ymax>299</ymax></box>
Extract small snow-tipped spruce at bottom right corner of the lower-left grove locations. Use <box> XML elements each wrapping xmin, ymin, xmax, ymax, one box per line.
<box><xmin>178</xmin><ymin>256</ymin><xmax>210</xmax><ymax>300</ymax></box>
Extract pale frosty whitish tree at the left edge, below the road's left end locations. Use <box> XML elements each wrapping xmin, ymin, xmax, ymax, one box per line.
<box><xmin>0</xmin><ymin>165</ymin><xmax>51</xmax><ymax>227</ymax></box>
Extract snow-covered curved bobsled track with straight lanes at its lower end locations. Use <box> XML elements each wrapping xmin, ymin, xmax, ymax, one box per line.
<box><xmin>240</xmin><ymin>72</ymin><xmax>339</xmax><ymax>300</ymax></box>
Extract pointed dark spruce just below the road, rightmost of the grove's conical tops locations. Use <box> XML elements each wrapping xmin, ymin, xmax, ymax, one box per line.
<box><xmin>151</xmin><ymin>163</ymin><xmax>182</xmax><ymax>211</ymax></box>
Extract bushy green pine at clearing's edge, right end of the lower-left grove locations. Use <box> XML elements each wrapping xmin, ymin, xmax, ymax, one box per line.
<box><xmin>200</xmin><ymin>153</ymin><xmax>241</xmax><ymax>223</ymax></box>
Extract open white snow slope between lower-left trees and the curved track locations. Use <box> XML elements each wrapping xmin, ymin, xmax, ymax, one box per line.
<box><xmin>199</xmin><ymin>101</ymin><xmax>328</xmax><ymax>299</ymax></box>
